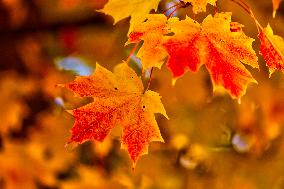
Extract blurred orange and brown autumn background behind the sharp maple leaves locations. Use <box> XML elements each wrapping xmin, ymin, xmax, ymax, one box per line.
<box><xmin>0</xmin><ymin>0</ymin><xmax>284</xmax><ymax>189</ymax></box>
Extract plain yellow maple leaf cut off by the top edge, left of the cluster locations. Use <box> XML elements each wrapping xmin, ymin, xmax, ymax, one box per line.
<box><xmin>99</xmin><ymin>0</ymin><xmax>160</xmax><ymax>31</ymax></box>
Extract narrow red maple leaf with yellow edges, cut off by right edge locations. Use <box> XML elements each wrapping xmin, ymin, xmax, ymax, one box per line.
<box><xmin>258</xmin><ymin>25</ymin><xmax>284</xmax><ymax>76</ymax></box>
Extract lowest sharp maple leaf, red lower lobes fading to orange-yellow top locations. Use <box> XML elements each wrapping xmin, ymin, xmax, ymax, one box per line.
<box><xmin>65</xmin><ymin>63</ymin><xmax>167</xmax><ymax>165</ymax></box>
